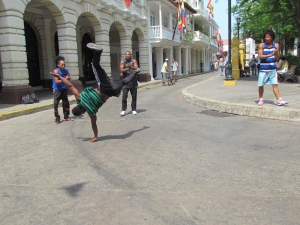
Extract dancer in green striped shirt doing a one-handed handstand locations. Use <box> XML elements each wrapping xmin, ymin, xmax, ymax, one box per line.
<box><xmin>50</xmin><ymin>43</ymin><xmax>139</xmax><ymax>142</ymax></box>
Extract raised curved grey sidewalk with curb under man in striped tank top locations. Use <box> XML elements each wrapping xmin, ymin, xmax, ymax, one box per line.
<box><xmin>182</xmin><ymin>72</ymin><xmax>300</xmax><ymax>121</ymax></box>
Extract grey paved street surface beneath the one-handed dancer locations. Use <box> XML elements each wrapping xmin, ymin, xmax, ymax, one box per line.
<box><xmin>0</xmin><ymin>74</ymin><xmax>300</xmax><ymax>225</ymax></box>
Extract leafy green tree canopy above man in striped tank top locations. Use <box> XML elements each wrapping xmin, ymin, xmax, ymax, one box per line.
<box><xmin>216</xmin><ymin>0</ymin><xmax>300</xmax><ymax>49</ymax></box>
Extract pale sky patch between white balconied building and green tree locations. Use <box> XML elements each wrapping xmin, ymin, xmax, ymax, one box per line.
<box><xmin>212</xmin><ymin>0</ymin><xmax>236</xmax><ymax>39</ymax></box>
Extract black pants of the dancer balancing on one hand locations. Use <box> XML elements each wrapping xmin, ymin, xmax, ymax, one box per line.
<box><xmin>92</xmin><ymin>51</ymin><xmax>135</xmax><ymax>97</ymax></box>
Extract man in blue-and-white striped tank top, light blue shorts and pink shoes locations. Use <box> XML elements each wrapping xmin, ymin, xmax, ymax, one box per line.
<box><xmin>257</xmin><ymin>30</ymin><xmax>289</xmax><ymax>106</ymax></box>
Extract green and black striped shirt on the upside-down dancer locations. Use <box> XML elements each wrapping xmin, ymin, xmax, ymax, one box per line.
<box><xmin>77</xmin><ymin>87</ymin><xmax>105</xmax><ymax>116</ymax></box>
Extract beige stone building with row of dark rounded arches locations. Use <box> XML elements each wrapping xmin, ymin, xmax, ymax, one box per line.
<box><xmin>0</xmin><ymin>0</ymin><xmax>149</xmax><ymax>103</ymax></box>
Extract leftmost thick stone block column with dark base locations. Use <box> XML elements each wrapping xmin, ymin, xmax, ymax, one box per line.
<box><xmin>0</xmin><ymin>8</ymin><xmax>33</xmax><ymax>104</ymax></box>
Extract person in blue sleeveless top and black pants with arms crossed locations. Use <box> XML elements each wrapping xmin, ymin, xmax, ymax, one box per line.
<box><xmin>52</xmin><ymin>56</ymin><xmax>73</xmax><ymax>125</ymax></box>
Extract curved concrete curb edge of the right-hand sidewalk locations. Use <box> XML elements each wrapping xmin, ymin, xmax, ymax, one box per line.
<box><xmin>181</xmin><ymin>88</ymin><xmax>300</xmax><ymax>121</ymax></box>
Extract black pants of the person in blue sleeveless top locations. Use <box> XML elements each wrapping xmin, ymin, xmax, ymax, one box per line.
<box><xmin>53</xmin><ymin>89</ymin><xmax>70</xmax><ymax>119</ymax></box>
